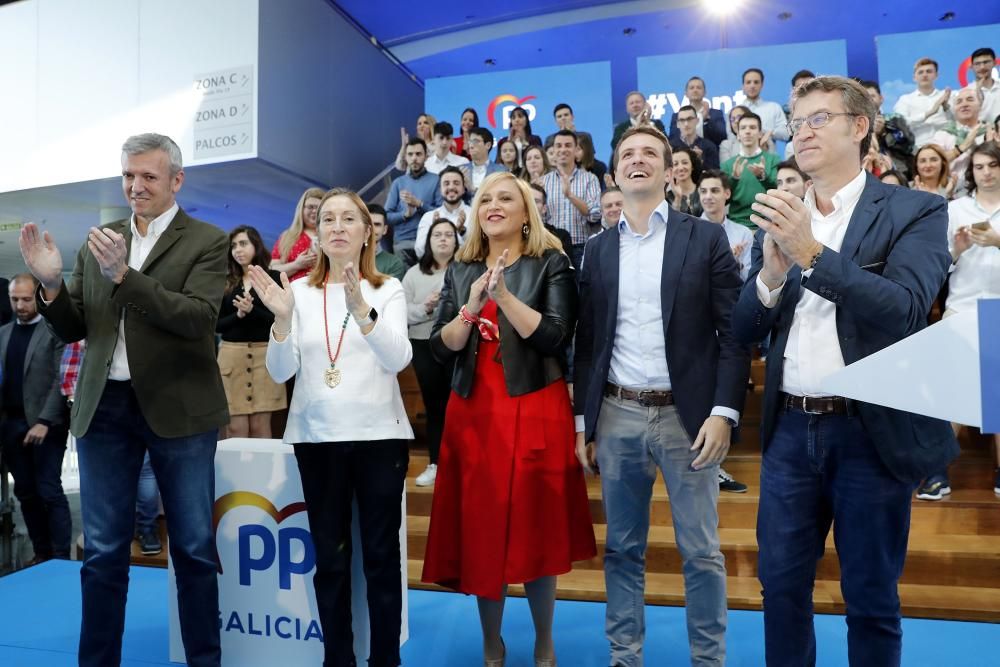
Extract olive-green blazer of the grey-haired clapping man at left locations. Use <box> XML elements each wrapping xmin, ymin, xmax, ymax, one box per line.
<box><xmin>39</xmin><ymin>210</ymin><xmax>229</xmax><ymax>438</ymax></box>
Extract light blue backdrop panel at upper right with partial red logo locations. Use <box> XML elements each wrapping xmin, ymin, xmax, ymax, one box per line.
<box><xmin>875</xmin><ymin>24</ymin><xmax>1000</xmax><ymax>111</ymax></box>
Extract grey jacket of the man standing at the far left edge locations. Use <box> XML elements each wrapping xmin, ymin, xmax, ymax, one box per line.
<box><xmin>0</xmin><ymin>322</ymin><xmax>66</xmax><ymax>426</ymax></box>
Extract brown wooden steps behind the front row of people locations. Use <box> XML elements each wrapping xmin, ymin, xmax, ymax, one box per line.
<box><xmin>133</xmin><ymin>361</ymin><xmax>1000</xmax><ymax>622</ymax></box>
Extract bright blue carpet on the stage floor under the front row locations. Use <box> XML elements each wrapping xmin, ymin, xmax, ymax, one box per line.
<box><xmin>0</xmin><ymin>561</ymin><xmax>1000</xmax><ymax>667</ymax></box>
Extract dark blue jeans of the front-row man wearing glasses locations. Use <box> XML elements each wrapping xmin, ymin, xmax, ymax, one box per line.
<box><xmin>757</xmin><ymin>410</ymin><xmax>914</xmax><ymax>667</ymax></box>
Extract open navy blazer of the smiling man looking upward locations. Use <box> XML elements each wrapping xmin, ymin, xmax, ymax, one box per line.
<box><xmin>573</xmin><ymin>209</ymin><xmax>750</xmax><ymax>442</ymax></box>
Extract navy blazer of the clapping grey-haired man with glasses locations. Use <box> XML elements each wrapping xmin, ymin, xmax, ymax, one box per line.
<box><xmin>733</xmin><ymin>174</ymin><xmax>958</xmax><ymax>483</ymax></box>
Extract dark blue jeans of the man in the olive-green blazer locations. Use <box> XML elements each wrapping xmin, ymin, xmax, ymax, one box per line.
<box><xmin>77</xmin><ymin>380</ymin><xmax>221</xmax><ymax>667</ymax></box>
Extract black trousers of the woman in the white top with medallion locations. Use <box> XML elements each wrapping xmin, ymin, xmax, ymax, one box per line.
<box><xmin>295</xmin><ymin>440</ymin><xmax>409</xmax><ymax>667</ymax></box>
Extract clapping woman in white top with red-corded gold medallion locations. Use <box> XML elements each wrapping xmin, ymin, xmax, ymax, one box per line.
<box><xmin>251</xmin><ymin>189</ymin><xmax>413</xmax><ymax>667</ymax></box>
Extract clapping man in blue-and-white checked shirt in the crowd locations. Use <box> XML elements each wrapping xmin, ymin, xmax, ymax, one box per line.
<box><xmin>542</xmin><ymin>130</ymin><xmax>601</xmax><ymax>271</ymax></box>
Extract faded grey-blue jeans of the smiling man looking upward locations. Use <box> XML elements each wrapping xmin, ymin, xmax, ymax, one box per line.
<box><xmin>596</xmin><ymin>397</ymin><xmax>726</xmax><ymax>667</ymax></box>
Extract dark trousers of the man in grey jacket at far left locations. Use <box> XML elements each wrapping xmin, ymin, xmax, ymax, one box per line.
<box><xmin>0</xmin><ymin>417</ymin><xmax>72</xmax><ymax>559</ymax></box>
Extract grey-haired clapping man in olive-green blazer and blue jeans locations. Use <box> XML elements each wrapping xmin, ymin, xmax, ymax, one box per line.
<box><xmin>21</xmin><ymin>134</ymin><xmax>229</xmax><ymax>667</ymax></box>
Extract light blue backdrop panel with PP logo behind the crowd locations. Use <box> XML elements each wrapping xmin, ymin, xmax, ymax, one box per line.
<box><xmin>424</xmin><ymin>62</ymin><xmax>612</xmax><ymax>159</ymax></box>
